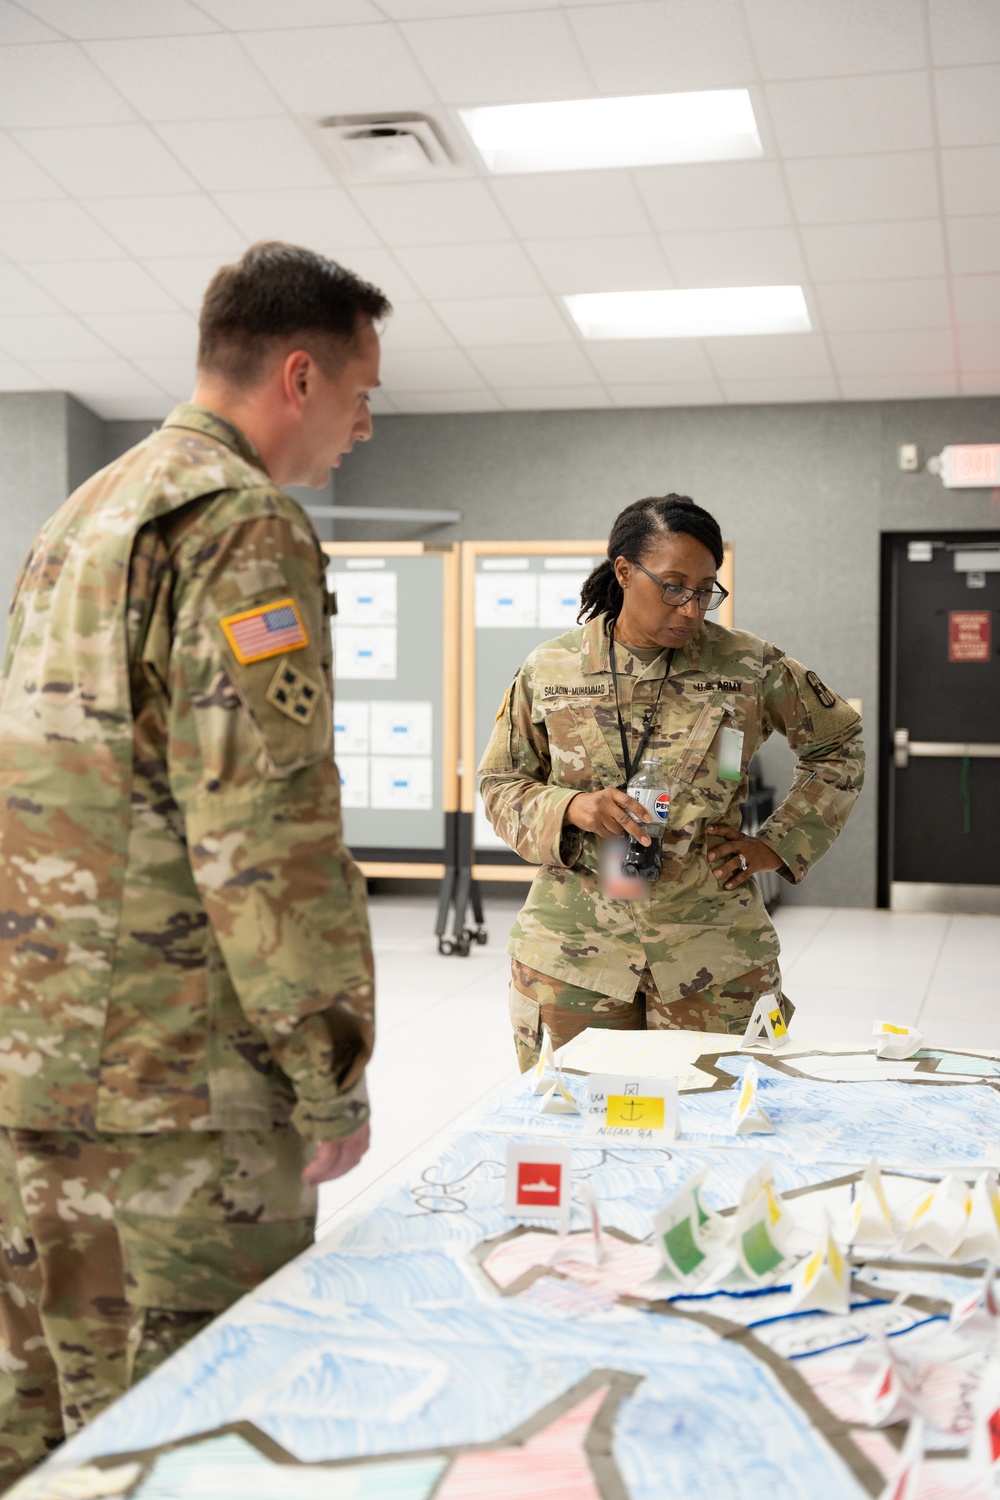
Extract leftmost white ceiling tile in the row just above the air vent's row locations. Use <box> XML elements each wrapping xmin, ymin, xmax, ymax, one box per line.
<box><xmin>0</xmin><ymin>42</ymin><xmax>135</xmax><ymax>129</ymax></box>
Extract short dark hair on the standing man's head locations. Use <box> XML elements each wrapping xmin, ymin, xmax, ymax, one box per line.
<box><xmin>198</xmin><ymin>240</ymin><xmax>393</xmax><ymax>387</ymax></box>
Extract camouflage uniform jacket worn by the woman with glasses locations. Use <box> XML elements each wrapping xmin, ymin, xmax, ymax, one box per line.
<box><xmin>480</xmin><ymin>615</ymin><xmax>864</xmax><ymax>1002</ymax></box>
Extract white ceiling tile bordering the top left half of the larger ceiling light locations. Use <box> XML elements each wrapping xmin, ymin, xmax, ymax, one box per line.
<box><xmin>400</xmin><ymin>11</ymin><xmax>594</xmax><ymax>105</ymax></box>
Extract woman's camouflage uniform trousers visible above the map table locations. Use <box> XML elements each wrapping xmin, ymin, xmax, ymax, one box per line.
<box><xmin>510</xmin><ymin>959</ymin><xmax>795</xmax><ymax>1073</ymax></box>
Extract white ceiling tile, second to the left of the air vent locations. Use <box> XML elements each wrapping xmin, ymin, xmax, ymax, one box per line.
<box><xmin>15</xmin><ymin>125</ymin><xmax>204</xmax><ymax>198</ymax></box>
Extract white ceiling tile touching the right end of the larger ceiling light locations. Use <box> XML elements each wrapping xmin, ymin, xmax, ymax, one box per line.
<box><xmin>768</xmin><ymin>73</ymin><xmax>934</xmax><ymax>158</ymax></box>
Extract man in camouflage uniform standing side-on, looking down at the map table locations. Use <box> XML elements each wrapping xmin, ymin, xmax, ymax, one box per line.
<box><xmin>0</xmin><ymin>243</ymin><xmax>390</xmax><ymax>1490</ymax></box>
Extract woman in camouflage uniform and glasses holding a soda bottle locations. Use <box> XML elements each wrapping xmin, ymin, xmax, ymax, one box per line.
<box><xmin>480</xmin><ymin>495</ymin><xmax>864</xmax><ymax>1071</ymax></box>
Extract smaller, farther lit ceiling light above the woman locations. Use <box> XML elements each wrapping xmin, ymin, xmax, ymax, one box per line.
<box><xmin>562</xmin><ymin>287</ymin><xmax>813</xmax><ymax>339</ymax></box>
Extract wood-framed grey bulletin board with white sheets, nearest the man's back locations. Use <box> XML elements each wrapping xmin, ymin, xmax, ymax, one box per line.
<box><xmin>324</xmin><ymin>542</ymin><xmax>459</xmax><ymax>881</ymax></box>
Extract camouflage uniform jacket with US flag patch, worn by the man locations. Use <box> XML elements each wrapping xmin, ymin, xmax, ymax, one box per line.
<box><xmin>0</xmin><ymin>407</ymin><xmax>373</xmax><ymax>1140</ymax></box>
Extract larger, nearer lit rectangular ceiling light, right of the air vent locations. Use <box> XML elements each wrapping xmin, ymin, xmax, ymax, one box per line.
<box><xmin>459</xmin><ymin>89</ymin><xmax>763</xmax><ymax>173</ymax></box>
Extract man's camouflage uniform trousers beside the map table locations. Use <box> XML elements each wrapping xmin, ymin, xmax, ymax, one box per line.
<box><xmin>0</xmin><ymin>1127</ymin><xmax>316</xmax><ymax>1491</ymax></box>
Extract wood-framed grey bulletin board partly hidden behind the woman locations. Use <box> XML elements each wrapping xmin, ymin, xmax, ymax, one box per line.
<box><xmin>462</xmin><ymin>540</ymin><xmax>733</xmax><ymax>881</ymax></box>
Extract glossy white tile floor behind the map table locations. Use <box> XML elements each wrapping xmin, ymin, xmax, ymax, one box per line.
<box><xmin>318</xmin><ymin>896</ymin><xmax>1000</xmax><ymax>1235</ymax></box>
